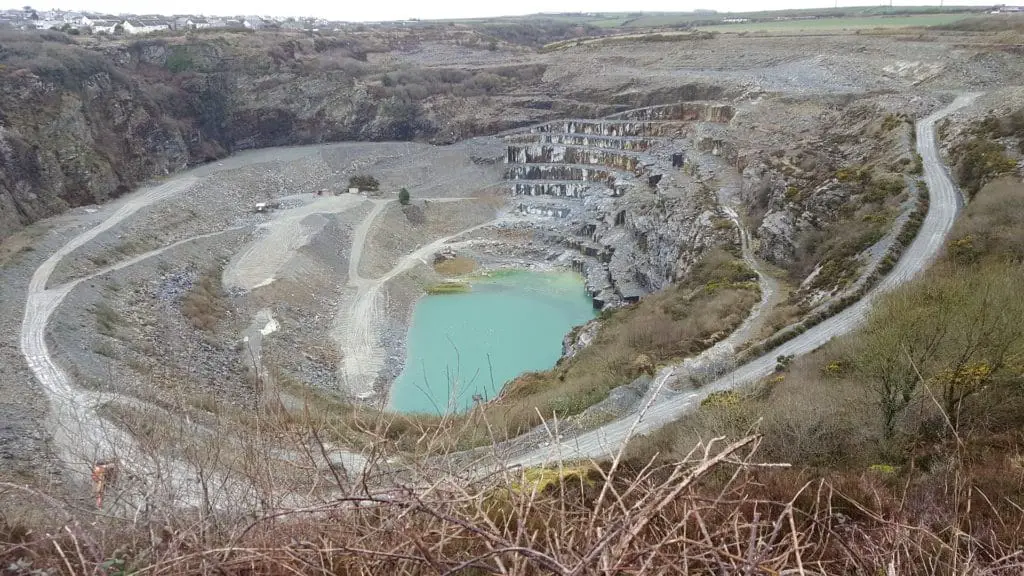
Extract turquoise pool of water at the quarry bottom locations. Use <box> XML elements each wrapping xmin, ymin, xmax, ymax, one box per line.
<box><xmin>389</xmin><ymin>271</ymin><xmax>595</xmax><ymax>414</ymax></box>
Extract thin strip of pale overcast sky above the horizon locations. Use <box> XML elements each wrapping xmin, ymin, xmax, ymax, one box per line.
<box><xmin>8</xmin><ymin>0</ymin><xmax>999</xmax><ymax>22</ymax></box>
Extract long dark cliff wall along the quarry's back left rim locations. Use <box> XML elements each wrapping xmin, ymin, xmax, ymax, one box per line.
<box><xmin>0</xmin><ymin>31</ymin><xmax>569</xmax><ymax>239</ymax></box>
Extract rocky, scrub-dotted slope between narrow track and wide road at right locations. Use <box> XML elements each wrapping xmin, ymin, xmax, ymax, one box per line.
<box><xmin>733</xmin><ymin>96</ymin><xmax>933</xmax><ymax>306</ymax></box>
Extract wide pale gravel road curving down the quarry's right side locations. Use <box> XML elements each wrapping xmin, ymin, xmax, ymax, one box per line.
<box><xmin>506</xmin><ymin>94</ymin><xmax>978</xmax><ymax>466</ymax></box>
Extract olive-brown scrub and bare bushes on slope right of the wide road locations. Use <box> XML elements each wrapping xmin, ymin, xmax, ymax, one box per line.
<box><xmin>630</xmin><ymin>174</ymin><xmax>1024</xmax><ymax>574</ymax></box>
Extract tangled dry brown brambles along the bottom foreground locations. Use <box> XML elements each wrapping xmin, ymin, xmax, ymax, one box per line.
<box><xmin>6</xmin><ymin>430</ymin><xmax>897</xmax><ymax>576</ymax></box>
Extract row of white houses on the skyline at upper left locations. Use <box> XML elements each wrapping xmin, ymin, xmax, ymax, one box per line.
<box><xmin>0</xmin><ymin>6</ymin><xmax>336</xmax><ymax>35</ymax></box>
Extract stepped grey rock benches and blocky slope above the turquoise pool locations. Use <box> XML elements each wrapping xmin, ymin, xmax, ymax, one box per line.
<box><xmin>505</xmin><ymin>102</ymin><xmax>738</xmax><ymax>309</ymax></box>
